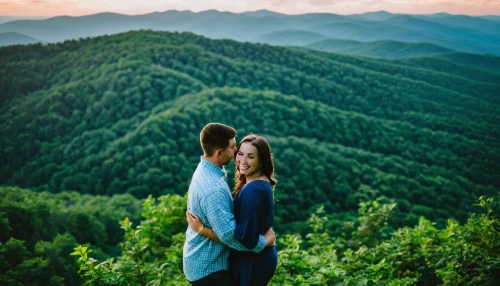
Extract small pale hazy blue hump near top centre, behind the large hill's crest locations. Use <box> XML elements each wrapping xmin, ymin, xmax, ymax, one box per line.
<box><xmin>254</xmin><ymin>30</ymin><xmax>328</xmax><ymax>46</ymax></box>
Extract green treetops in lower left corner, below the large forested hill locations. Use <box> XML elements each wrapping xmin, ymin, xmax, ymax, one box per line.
<box><xmin>0</xmin><ymin>187</ymin><xmax>142</xmax><ymax>286</ymax></box>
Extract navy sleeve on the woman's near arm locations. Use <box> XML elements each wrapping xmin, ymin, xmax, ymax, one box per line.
<box><xmin>234</xmin><ymin>185</ymin><xmax>264</xmax><ymax>248</ymax></box>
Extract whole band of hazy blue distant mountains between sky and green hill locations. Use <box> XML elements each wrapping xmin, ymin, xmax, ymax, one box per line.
<box><xmin>0</xmin><ymin>10</ymin><xmax>500</xmax><ymax>55</ymax></box>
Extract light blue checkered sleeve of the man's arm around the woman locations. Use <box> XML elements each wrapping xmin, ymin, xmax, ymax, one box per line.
<box><xmin>200</xmin><ymin>190</ymin><xmax>266</xmax><ymax>253</ymax></box>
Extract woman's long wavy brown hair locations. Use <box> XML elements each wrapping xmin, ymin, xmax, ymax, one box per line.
<box><xmin>232</xmin><ymin>134</ymin><xmax>278</xmax><ymax>197</ymax></box>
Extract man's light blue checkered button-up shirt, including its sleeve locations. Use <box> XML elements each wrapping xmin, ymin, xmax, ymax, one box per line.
<box><xmin>183</xmin><ymin>156</ymin><xmax>266</xmax><ymax>281</ymax></box>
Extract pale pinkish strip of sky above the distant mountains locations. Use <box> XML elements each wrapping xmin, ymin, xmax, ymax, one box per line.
<box><xmin>0</xmin><ymin>0</ymin><xmax>500</xmax><ymax>16</ymax></box>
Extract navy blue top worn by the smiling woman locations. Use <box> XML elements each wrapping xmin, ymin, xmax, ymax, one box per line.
<box><xmin>231</xmin><ymin>180</ymin><xmax>278</xmax><ymax>286</ymax></box>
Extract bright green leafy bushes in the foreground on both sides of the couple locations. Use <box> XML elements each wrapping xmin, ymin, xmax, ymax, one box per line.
<box><xmin>71</xmin><ymin>195</ymin><xmax>500</xmax><ymax>285</ymax></box>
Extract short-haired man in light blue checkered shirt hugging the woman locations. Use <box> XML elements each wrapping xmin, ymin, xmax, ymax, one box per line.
<box><xmin>183</xmin><ymin>123</ymin><xmax>276</xmax><ymax>286</ymax></box>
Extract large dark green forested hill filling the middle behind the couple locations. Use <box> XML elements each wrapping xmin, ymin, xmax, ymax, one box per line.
<box><xmin>0</xmin><ymin>31</ymin><xmax>500</xmax><ymax>235</ymax></box>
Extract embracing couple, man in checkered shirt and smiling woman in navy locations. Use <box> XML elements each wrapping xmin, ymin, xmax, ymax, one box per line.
<box><xmin>183</xmin><ymin>123</ymin><xmax>278</xmax><ymax>286</ymax></box>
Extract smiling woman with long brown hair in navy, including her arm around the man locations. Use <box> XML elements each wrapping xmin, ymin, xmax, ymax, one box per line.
<box><xmin>187</xmin><ymin>134</ymin><xmax>278</xmax><ymax>286</ymax></box>
